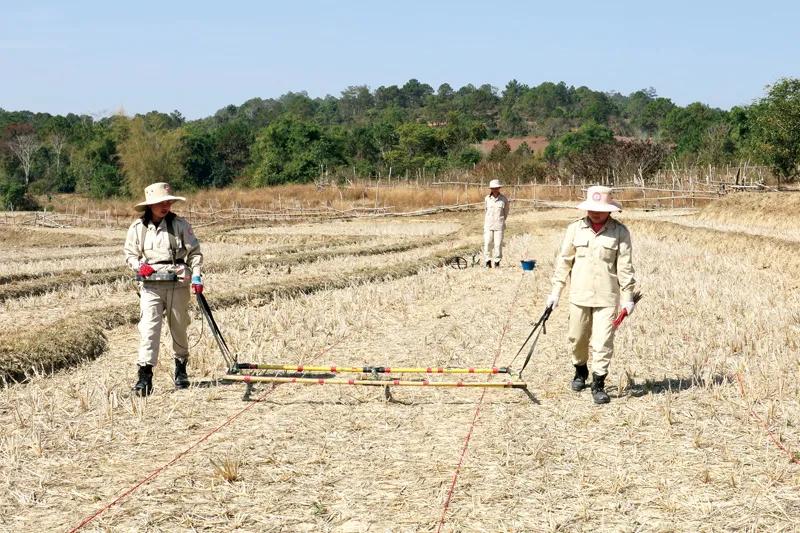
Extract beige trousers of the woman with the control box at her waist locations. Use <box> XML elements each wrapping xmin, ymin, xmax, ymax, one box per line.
<box><xmin>137</xmin><ymin>282</ymin><xmax>191</xmax><ymax>366</ymax></box>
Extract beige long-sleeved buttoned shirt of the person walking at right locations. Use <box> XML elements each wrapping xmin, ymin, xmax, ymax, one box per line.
<box><xmin>553</xmin><ymin>217</ymin><xmax>636</xmax><ymax>307</ymax></box>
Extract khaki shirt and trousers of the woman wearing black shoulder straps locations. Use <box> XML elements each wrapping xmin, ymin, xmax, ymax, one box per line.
<box><xmin>124</xmin><ymin>216</ymin><xmax>203</xmax><ymax>366</ymax></box>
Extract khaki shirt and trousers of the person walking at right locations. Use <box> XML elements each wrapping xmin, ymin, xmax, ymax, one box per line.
<box><xmin>553</xmin><ymin>217</ymin><xmax>636</xmax><ymax>376</ymax></box>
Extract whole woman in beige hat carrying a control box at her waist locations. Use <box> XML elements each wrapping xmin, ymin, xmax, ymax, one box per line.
<box><xmin>125</xmin><ymin>183</ymin><xmax>203</xmax><ymax>396</ymax></box>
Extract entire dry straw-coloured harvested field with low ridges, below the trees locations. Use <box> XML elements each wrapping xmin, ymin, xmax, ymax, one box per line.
<box><xmin>0</xmin><ymin>195</ymin><xmax>800</xmax><ymax>533</ymax></box>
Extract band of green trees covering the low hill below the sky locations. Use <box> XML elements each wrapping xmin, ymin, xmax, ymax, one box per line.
<box><xmin>0</xmin><ymin>78</ymin><xmax>800</xmax><ymax>209</ymax></box>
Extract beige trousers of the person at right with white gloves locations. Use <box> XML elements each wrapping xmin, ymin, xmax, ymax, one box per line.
<box><xmin>567</xmin><ymin>303</ymin><xmax>617</xmax><ymax>376</ymax></box>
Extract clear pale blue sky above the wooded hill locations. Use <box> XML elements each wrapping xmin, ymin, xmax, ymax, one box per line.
<box><xmin>0</xmin><ymin>0</ymin><xmax>800</xmax><ymax>119</ymax></box>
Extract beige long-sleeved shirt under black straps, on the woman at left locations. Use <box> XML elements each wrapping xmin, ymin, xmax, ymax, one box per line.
<box><xmin>125</xmin><ymin>216</ymin><xmax>203</xmax><ymax>276</ymax></box>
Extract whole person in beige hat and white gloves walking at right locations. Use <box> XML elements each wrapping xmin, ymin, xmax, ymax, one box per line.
<box><xmin>547</xmin><ymin>186</ymin><xmax>636</xmax><ymax>404</ymax></box>
